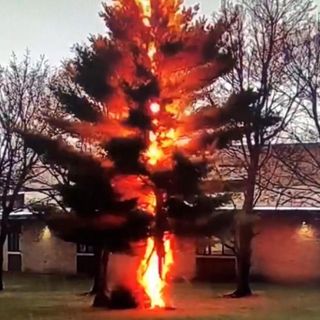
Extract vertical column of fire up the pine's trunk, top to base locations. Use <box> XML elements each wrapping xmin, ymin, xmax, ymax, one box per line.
<box><xmin>136</xmin><ymin>0</ymin><xmax>174</xmax><ymax>308</ymax></box>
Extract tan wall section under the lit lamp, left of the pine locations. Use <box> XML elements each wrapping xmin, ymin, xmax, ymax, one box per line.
<box><xmin>21</xmin><ymin>222</ymin><xmax>76</xmax><ymax>274</ymax></box>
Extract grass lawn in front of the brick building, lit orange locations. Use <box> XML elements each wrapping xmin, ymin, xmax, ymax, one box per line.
<box><xmin>0</xmin><ymin>275</ymin><xmax>320</xmax><ymax>320</ymax></box>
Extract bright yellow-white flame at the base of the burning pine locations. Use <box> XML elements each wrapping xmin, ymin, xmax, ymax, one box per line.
<box><xmin>138</xmin><ymin>234</ymin><xmax>173</xmax><ymax>309</ymax></box>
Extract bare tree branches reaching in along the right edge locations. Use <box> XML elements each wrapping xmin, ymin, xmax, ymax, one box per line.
<box><xmin>277</xmin><ymin>17</ymin><xmax>320</xmax><ymax>206</ymax></box>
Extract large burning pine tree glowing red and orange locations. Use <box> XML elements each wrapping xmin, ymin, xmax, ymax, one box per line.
<box><xmin>23</xmin><ymin>0</ymin><xmax>252</xmax><ymax>308</ymax></box>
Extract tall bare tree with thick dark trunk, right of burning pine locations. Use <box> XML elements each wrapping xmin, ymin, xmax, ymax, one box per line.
<box><xmin>209</xmin><ymin>0</ymin><xmax>313</xmax><ymax>297</ymax></box>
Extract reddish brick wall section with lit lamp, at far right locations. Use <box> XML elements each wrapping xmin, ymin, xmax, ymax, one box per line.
<box><xmin>252</xmin><ymin>215</ymin><xmax>320</xmax><ymax>283</ymax></box>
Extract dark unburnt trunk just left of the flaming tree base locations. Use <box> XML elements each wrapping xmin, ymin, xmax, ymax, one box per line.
<box><xmin>93</xmin><ymin>250</ymin><xmax>110</xmax><ymax>308</ymax></box>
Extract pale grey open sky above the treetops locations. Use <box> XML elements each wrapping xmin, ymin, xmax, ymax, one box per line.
<box><xmin>0</xmin><ymin>0</ymin><xmax>221</xmax><ymax>66</ymax></box>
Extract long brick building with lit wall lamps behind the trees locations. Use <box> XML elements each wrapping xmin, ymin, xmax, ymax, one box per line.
<box><xmin>0</xmin><ymin>146</ymin><xmax>320</xmax><ymax>282</ymax></box>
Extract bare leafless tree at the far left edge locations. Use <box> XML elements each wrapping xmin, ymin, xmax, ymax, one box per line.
<box><xmin>0</xmin><ymin>54</ymin><xmax>51</xmax><ymax>290</ymax></box>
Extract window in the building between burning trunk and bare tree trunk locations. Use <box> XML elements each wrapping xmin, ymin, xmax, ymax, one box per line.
<box><xmin>197</xmin><ymin>237</ymin><xmax>234</xmax><ymax>256</ymax></box>
